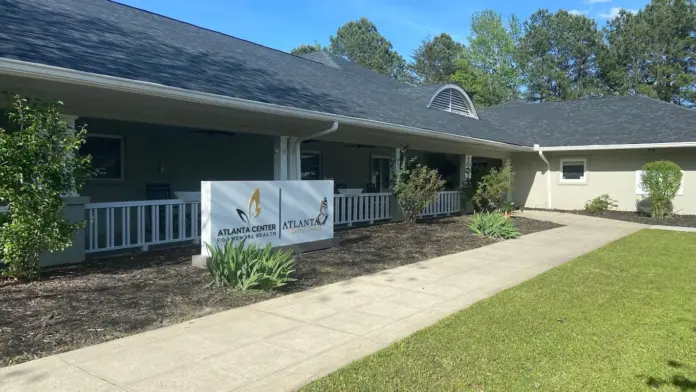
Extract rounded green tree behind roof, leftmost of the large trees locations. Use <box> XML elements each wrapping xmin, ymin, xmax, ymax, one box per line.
<box><xmin>329</xmin><ymin>18</ymin><xmax>408</xmax><ymax>80</ymax></box>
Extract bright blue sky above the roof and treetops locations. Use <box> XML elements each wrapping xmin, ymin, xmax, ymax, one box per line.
<box><xmin>117</xmin><ymin>0</ymin><xmax>648</xmax><ymax>59</ymax></box>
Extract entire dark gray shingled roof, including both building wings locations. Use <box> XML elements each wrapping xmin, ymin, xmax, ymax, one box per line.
<box><xmin>0</xmin><ymin>0</ymin><xmax>696</xmax><ymax>146</ymax></box>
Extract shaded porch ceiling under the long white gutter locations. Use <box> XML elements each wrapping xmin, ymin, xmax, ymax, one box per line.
<box><xmin>0</xmin><ymin>75</ymin><xmax>509</xmax><ymax>157</ymax></box>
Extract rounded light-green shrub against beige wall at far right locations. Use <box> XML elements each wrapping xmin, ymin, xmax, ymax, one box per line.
<box><xmin>640</xmin><ymin>161</ymin><xmax>682</xmax><ymax>218</ymax></box>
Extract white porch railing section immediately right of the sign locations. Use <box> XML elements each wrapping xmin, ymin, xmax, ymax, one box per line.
<box><xmin>334</xmin><ymin>193</ymin><xmax>392</xmax><ymax>226</ymax></box>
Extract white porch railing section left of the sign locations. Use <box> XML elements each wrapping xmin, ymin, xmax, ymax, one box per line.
<box><xmin>85</xmin><ymin>199</ymin><xmax>201</xmax><ymax>253</ymax></box>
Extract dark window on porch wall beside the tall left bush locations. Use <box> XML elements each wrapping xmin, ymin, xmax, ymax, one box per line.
<box><xmin>80</xmin><ymin>135</ymin><xmax>123</xmax><ymax>180</ymax></box>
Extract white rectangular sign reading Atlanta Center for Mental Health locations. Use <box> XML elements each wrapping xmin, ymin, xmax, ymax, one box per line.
<box><xmin>201</xmin><ymin>181</ymin><xmax>334</xmax><ymax>254</ymax></box>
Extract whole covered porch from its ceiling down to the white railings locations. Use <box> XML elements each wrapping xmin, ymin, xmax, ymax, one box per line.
<box><xmin>3</xmin><ymin>72</ymin><xmax>512</xmax><ymax>253</ymax></box>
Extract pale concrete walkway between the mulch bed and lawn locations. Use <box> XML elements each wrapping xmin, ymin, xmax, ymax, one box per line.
<box><xmin>0</xmin><ymin>211</ymin><xmax>646</xmax><ymax>392</ymax></box>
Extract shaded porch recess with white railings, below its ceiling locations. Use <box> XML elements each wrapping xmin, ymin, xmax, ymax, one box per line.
<box><xmin>75</xmin><ymin>118</ymin><xmax>502</xmax><ymax>254</ymax></box>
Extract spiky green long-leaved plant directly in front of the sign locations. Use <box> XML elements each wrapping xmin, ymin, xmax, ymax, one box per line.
<box><xmin>206</xmin><ymin>241</ymin><xmax>295</xmax><ymax>291</ymax></box>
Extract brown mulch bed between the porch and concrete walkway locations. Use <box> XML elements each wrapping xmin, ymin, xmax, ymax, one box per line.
<box><xmin>0</xmin><ymin>216</ymin><xmax>559</xmax><ymax>367</ymax></box>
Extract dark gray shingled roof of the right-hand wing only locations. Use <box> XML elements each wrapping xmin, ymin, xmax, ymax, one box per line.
<box><xmin>478</xmin><ymin>96</ymin><xmax>696</xmax><ymax>146</ymax></box>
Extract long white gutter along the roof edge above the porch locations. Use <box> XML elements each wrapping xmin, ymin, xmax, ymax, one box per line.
<box><xmin>0</xmin><ymin>58</ymin><xmax>532</xmax><ymax>151</ymax></box>
